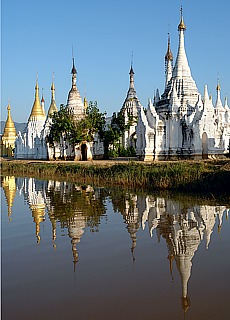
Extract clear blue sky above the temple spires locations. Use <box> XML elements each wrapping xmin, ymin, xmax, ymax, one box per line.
<box><xmin>1</xmin><ymin>0</ymin><xmax>230</xmax><ymax>122</ymax></box>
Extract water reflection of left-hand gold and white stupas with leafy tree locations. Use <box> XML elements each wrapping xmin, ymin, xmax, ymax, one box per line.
<box><xmin>6</xmin><ymin>177</ymin><xmax>106</xmax><ymax>270</ymax></box>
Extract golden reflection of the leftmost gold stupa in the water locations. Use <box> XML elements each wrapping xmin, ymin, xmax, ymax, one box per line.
<box><xmin>2</xmin><ymin>176</ymin><xmax>16</xmax><ymax>221</ymax></box>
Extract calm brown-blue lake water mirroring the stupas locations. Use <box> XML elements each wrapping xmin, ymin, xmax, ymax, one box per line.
<box><xmin>1</xmin><ymin>176</ymin><xmax>230</xmax><ymax>320</ymax></box>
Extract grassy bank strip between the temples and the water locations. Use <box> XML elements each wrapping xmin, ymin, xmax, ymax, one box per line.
<box><xmin>1</xmin><ymin>160</ymin><xmax>230</xmax><ymax>196</ymax></box>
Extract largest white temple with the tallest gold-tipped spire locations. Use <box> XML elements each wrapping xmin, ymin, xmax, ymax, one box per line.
<box><xmin>136</xmin><ymin>9</ymin><xmax>230</xmax><ymax>161</ymax></box>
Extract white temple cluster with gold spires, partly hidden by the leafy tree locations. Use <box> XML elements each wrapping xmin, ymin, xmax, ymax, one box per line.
<box><xmin>15</xmin><ymin>59</ymin><xmax>104</xmax><ymax>160</ymax></box>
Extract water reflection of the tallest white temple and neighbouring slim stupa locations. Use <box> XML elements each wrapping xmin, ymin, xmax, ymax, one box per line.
<box><xmin>119</xmin><ymin>192</ymin><xmax>228</xmax><ymax>312</ymax></box>
